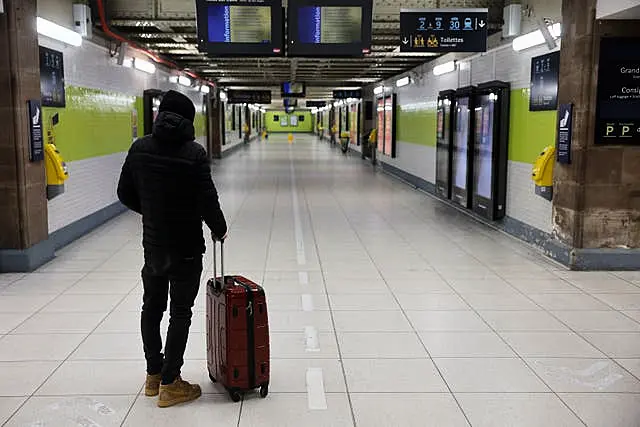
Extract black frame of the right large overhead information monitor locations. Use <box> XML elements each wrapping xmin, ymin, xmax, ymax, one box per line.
<box><xmin>287</xmin><ymin>0</ymin><xmax>373</xmax><ymax>58</ymax></box>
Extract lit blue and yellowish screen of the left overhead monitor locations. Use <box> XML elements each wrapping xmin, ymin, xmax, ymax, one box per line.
<box><xmin>208</xmin><ymin>5</ymin><xmax>271</xmax><ymax>44</ymax></box>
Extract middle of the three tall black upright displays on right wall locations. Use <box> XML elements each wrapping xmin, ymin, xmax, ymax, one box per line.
<box><xmin>451</xmin><ymin>86</ymin><xmax>476</xmax><ymax>208</ymax></box>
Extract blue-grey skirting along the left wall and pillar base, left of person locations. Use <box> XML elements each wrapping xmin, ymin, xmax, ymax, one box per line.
<box><xmin>0</xmin><ymin>202</ymin><xmax>126</xmax><ymax>273</ymax></box>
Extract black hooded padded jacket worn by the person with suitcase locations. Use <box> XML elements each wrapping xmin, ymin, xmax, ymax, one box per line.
<box><xmin>118</xmin><ymin>111</ymin><xmax>227</xmax><ymax>255</ymax></box>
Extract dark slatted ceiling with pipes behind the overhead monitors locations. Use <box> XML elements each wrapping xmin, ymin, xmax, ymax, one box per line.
<box><xmin>105</xmin><ymin>0</ymin><xmax>505</xmax><ymax>99</ymax></box>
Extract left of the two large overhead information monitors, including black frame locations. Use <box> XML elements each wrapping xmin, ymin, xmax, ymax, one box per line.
<box><xmin>196</xmin><ymin>0</ymin><xmax>284</xmax><ymax>56</ymax></box>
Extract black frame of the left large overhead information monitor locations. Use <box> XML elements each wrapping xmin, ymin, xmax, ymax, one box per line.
<box><xmin>196</xmin><ymin>0</ymin><xmax>285</xmax><ymax>57</ymax></box>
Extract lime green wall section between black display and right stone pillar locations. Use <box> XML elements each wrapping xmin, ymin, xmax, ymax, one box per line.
<box><xmin>509</xmin><ymin>89</ymin><xmax>558</xmax><ymax>164</ymax></box>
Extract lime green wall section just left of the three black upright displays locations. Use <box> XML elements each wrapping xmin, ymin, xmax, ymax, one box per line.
<box><xmin>396</xmin><ymin>106</ymin><xmax>437</xmax><ymax>147</ymax></box>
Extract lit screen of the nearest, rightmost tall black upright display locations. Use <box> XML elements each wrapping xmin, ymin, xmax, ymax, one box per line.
<box><xmin>474</xmin><ymin>94</ymin><xmax>495</xmax><ymax>199</ymax></box>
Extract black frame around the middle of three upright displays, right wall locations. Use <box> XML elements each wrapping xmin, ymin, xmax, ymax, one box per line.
<box><xmin>450</xmin><ymin>86</ymin><xmax>476</xmax><ymax>209</ymax></box>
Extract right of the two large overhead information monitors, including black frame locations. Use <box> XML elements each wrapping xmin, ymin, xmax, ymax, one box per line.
<box><xmin>288</xmin><ymin>0</ymin><xmax>373</xmax><ymax>57</ymax></box>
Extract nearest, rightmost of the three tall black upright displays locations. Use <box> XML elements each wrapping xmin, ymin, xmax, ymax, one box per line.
<box><xmin>473</xmin><ymin>81</ymin><xmax>511</xmax><ymax>221</ymax></box>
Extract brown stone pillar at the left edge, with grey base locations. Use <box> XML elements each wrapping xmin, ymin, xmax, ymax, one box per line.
<box><xmin>0</xmin><ymin>0</ymin><xmax>53</xmax><ymax>272</ymax></box>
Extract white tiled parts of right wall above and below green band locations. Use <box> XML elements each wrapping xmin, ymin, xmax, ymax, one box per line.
<box><xmin>379</xmin><ymin>40</ymin><xmax>564</xmax><ymax>236</ymax></box>
